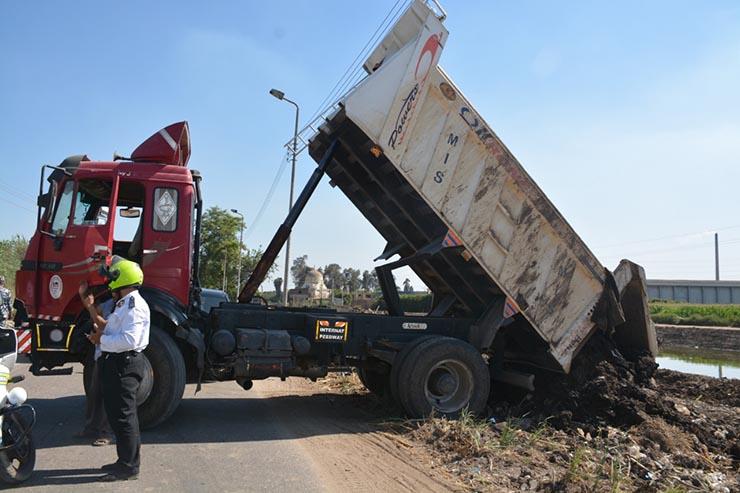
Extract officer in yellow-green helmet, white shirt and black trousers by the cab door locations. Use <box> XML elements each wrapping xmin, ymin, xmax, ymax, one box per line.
<box><xmin>80</xmin><ymin>257</ymin><xmax>150</xmax><ymax>481</ymax></box>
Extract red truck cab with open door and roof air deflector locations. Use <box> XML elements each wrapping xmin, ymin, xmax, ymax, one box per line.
<box><xmin>16</xmin><ymin>122</ymin><xmax>200</xmax><ymax>426</ymax></box>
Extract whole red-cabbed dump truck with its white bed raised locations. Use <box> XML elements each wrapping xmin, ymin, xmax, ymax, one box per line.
<box><xmin>16</xmin><ymin>0</ymin><xmax>655</xmax><ymax>427</ymax></box>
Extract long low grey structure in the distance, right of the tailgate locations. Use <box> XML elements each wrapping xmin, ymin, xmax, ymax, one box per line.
<box><xmin>647</xmin><ymin>279</ymin><xmax>740</xmax><ymax>305</ymax></box>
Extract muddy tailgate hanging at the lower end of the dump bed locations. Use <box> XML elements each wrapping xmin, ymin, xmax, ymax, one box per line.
<box><xmin>614</xmin><ymin>260</ymin><xmax>658</xmax><ymax>359</ymax></box>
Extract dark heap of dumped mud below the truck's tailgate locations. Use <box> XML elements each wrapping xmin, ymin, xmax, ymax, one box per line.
<box><xmin>516</xmin><ymin>330</ymin><xmax>740</xmax><ymax>466</ymax></box>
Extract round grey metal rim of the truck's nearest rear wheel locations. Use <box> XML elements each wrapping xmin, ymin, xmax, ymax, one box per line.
<box><xmin>424</xmin><ymin>359</ymin><xmax>473</xmax><ymax>413</ymax></box>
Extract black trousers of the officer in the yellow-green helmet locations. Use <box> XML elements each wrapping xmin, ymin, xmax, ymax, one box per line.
<box><xmin>100</xmin><ymin>351</ymin><xmax>144</xmax><ymax>474</ymax></box>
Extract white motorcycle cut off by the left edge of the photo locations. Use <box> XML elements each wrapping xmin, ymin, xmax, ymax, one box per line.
<box><xmin>0</xmin><ymin>327</ymin><xmax>36</xmax><ymax>484</ymax></box>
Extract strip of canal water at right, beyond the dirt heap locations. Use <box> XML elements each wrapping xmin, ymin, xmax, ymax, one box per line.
<box><xmin>656</xmin><ymin>347</ymin><xmax>740</xmax><ymax>379</ymax></box>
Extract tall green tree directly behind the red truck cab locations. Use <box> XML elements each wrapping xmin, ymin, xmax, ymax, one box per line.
<box><xmin>200</xmin><ymin>207</ymin><xmax>268</xmax><ymax>299</ymax></box>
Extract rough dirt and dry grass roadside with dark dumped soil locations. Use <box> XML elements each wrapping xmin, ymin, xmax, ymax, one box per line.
<box><xmin>324</xmin><ymin>336</ymin><xmax>740</xmax><ymax>492</ymax></box>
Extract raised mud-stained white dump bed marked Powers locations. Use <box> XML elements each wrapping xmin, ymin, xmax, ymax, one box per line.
<box><xmin>309</xmin><ymin>0</ymin><xmax>655</xmax><ymax>371</ymax></box>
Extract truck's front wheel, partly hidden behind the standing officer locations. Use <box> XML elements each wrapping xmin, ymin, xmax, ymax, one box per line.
<box><xmin>136</xmin><ymin>326</ymin><xmax>185</xmax><ymax>429</ymax></box>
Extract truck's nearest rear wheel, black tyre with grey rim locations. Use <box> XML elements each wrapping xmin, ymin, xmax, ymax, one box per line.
<box><xmin>399</xmin><ymin>337</ymin><xmax>491</xmax><ymax>418</ymax></box>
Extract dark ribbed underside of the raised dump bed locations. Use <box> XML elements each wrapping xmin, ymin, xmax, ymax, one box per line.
<box><xmin>309</xmin><ymin>111</ymin><xmax>502</xmax><ymax>317</ymax></box>
